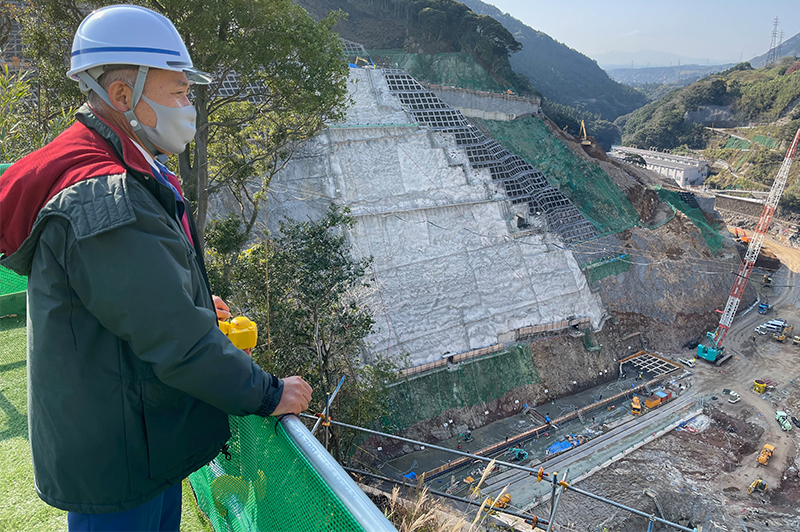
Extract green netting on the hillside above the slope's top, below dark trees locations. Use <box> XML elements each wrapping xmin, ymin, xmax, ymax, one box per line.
<box><xmin>368</xmin><ymin>50</ymin><xmax>506</xmax><ymax>92</ymax></box>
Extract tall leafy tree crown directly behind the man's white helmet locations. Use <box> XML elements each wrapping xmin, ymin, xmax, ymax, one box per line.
<box><xmin>22</xmin><ymin>0</ymin><xmax>347</xmax><ymax>242</ymax></box>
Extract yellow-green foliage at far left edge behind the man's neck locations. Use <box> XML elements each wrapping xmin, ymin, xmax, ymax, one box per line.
<box><xmin>0</xmin><ymin>67</ymin><xmax>73</xmax><ymax>163</ymax></box>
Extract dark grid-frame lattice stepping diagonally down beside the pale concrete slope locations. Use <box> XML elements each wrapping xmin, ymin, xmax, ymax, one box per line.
<box><xmin>383</xmin><ymin>69</ymin><xmax>597</xmax><ymax>243</ymax></box>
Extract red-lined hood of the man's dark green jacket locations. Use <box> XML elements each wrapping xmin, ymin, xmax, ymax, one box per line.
<box><xmin>0</xmin><ymin>105</ymin><xmax>152</xmax><ymax>259</ymax></box>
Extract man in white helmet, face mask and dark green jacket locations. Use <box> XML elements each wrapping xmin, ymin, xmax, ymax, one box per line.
<box><xmin>0</xmin><ymin>5</ymin><xmax>311</xmax><ymax>531</ymax></box>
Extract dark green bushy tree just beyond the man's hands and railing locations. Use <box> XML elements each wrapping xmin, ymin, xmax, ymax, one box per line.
<box><xmin>208</xmin><ymin>205</ymin><xmax>394</xmax><ymax>459</ymax></box>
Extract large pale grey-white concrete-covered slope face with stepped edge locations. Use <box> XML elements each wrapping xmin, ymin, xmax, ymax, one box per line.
<box><xmin>268</xmin><ymin>69</ymin><xmax>603</xmax><ymax>366</ymax></box>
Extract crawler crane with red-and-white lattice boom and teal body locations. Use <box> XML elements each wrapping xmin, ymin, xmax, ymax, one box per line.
<box><xmin>697</xmin><ymin>124</ymin><xmax>800</xmax><ymax>366</ymax></box>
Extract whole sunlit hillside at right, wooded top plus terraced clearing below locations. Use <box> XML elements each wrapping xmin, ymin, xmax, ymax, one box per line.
<box><xmin>616</xmin><ymin>58</ymin><xmax>800</xmax><ymax>206</ymax></box>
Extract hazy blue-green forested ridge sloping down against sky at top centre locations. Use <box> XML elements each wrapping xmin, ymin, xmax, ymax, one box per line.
<box><xmin>462</xmin><ymin>0</ymin><xmax>647</xmax><ymax>120</ymax></box>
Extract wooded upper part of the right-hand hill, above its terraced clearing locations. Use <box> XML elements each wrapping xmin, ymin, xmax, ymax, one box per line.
<box><xmin>616</xmin><ymin>58</ymin><xmax>800</xmax><ymax>150</ymax></box>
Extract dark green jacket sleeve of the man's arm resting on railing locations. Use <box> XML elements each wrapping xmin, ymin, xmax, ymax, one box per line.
<box><xmin>58</xmin><ymin>193</ymin><xmax>283</xmax><ymax>416</ymax></box>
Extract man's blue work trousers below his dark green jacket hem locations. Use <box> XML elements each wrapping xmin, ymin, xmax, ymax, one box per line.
<box><xmin>67</xmin><ymin>484</ymin><xmax>181</xmax><ymax>532</ymax></box>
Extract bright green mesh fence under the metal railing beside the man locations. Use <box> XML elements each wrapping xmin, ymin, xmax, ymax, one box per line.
<box><xmin>189</xmin><ymin>416</ymin><xmax>363</xmax><ymax>532</ymax></box>
